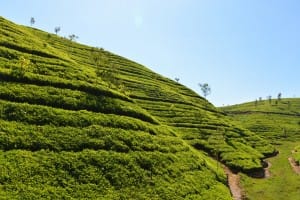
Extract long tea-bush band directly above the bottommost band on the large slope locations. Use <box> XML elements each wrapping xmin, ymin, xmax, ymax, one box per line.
<box><xmin>0</xmin><ymin>120</ymin><xmax>189</xmax><ymax>153</ymax></box>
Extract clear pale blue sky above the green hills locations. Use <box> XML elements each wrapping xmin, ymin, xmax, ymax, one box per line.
<box><xmin>0</xmin><ymin>0</ymin><xmax>300</xmax><ymax>106</ymax></box>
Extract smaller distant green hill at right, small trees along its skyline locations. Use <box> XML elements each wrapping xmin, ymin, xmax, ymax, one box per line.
<box><xmin>221</xmin><ymin>98</ymin><xmax>300</xmax><ymax>144</ymax></box>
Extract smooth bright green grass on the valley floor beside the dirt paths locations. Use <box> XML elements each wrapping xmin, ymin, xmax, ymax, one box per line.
<box><xmin>242</xmin><ymin>141</ymin><xmax>300</xmax><ymax>200</ymax></box>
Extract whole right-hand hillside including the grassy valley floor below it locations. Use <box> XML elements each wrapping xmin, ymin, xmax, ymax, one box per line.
<box><xmin>221</xmin><ymin>98</ymin><xmax>300</xmax><ymax>200</ymax></box>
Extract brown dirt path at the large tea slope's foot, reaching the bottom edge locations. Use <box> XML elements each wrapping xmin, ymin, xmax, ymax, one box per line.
<box><xmin>224</xmin><ymin>167</ymin><xmax>243</xmax><ymax>200</ymax></box>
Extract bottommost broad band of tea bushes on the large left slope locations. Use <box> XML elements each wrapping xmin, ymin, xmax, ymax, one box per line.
<box><xmin>0</xmin><ymin>150</ymin><xmax>230</xmax><ymax>199</ymax></box>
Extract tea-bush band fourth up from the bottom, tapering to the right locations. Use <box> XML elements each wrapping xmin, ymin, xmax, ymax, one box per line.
<box><xmin>0</xmin><ymin>82</ymin><xmax>157</xmax><ymax>123</ymax></box>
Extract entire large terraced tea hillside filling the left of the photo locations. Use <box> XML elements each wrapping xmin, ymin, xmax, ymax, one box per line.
<box><xmin>0</xmin><ymin>18</ymin><xmax>275</xmax><ymax>199</ymax></box>
